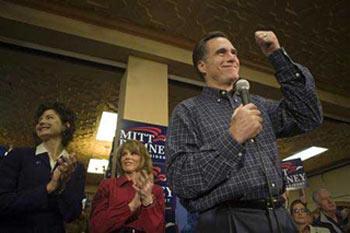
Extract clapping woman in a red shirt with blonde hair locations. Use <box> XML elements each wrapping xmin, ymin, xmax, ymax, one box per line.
<box><xmin>90</xmin><ymin>140</ymin><xmax>165</xmax><ymax>233</ymax></box>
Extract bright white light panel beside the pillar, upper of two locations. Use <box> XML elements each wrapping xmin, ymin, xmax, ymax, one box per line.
<box><xmin>96</xmin><ymin>112</ymin><xmax>118</xmax><ymax>142</ymax></box>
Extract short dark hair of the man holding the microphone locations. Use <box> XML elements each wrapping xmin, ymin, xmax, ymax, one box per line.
<box><xmin>192</xmin><ymin>31</ymin><xmax>228</xmax><ymax>78</ymax></box>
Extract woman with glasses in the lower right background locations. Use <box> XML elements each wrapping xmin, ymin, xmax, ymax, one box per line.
<box><xmin>290</xmin><ymin>199</ymin><xmax>330</xmax><ymax>233</ymax></box>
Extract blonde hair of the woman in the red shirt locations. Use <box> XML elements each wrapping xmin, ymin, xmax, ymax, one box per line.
<box><xmin>116</xmin><ymin>139</ymin><xmax>153</xmax><ymax>177</ymax></box>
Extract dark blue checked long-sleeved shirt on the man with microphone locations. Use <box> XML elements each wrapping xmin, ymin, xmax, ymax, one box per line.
<box><xmin>166</xmin><ymin>49</ymin><xmax>322</xmax><ymax>212</ymax></box>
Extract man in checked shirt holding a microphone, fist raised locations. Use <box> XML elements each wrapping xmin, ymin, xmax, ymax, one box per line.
<box><xmin>166</xmin><ymin>31</ymin><xmax>322</xmax><ymax>233</ymax></box>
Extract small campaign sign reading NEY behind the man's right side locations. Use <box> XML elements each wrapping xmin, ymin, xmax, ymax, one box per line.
<box><xmin>281</xmin><ymin>159</ymin><xmax>307</xmax><ymax>190</ymax></box>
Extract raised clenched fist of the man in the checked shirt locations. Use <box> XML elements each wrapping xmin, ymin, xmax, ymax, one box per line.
<box><xmin>255</xmin><ymin>31</ymin><xmax>281</xmax><ymax>57</ymax></box>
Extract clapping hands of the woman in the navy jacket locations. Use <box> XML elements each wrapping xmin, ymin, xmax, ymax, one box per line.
<box><xmin>46</xmin><ymin>153</ymin><xmax>77</xmax><ymax>193</ymax></box>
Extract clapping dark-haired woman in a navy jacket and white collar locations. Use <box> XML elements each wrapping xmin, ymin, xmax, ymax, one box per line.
<box><xmin>0</xmin><ymin>102</ymin><xmax>85</xmax><ymax>233</ymax></box>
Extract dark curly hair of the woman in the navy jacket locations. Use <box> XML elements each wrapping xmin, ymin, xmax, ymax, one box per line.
<box><xmin>34</xmin><ymin>102</ymin><xmax>76</xmax><ymax>146</ymax></box>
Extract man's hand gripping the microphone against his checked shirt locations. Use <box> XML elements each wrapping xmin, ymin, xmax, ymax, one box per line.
<box><xmin>230</xmin><ymin>103</ymin><xmax>263</xmax><ymax>144</ymax></box>
